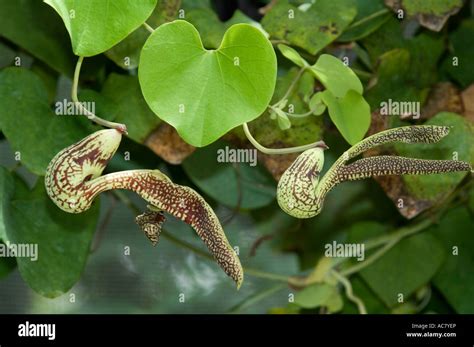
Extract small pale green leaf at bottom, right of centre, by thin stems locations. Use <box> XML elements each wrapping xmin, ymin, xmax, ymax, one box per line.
<box><xmin>295</xmin><ymin>283</ymin><xmax>342</xmax><ymax>310</ymax></box>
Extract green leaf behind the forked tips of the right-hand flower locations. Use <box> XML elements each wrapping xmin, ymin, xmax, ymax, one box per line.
<box><xmin>395</xmin><ymin>112</ymin><xmax>474</xmax><ymax>202</ymax></box>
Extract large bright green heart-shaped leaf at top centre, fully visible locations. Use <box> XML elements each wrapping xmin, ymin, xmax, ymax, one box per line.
<box><xmin>138</xmin><ymin>20</ymin><xmax>276</xmax><ymax>147</ymax></box>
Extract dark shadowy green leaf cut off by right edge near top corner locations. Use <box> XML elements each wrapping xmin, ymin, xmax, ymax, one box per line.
<box><xmin>444</xmin><ymin>19</ymin><xmax>474</xmax><ymax>87</ymax></box>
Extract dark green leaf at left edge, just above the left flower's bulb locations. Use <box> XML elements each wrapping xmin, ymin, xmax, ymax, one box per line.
<box><xmin>0</xmin><ymin>67</ymin><xmax>104</xmax><ymax>175</ymax></box>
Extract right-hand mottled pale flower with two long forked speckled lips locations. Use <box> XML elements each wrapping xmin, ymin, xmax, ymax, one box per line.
<box><xmin>277</xmin><ymin>125</ymin><xmax>472</xmax><ymax>218</ymax></box>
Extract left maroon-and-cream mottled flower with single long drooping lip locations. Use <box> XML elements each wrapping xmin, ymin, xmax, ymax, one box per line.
<box><xmin>45</xmin><ymin>129</ymin><xmax>243</xmax><ymax>288</ymax></box>
